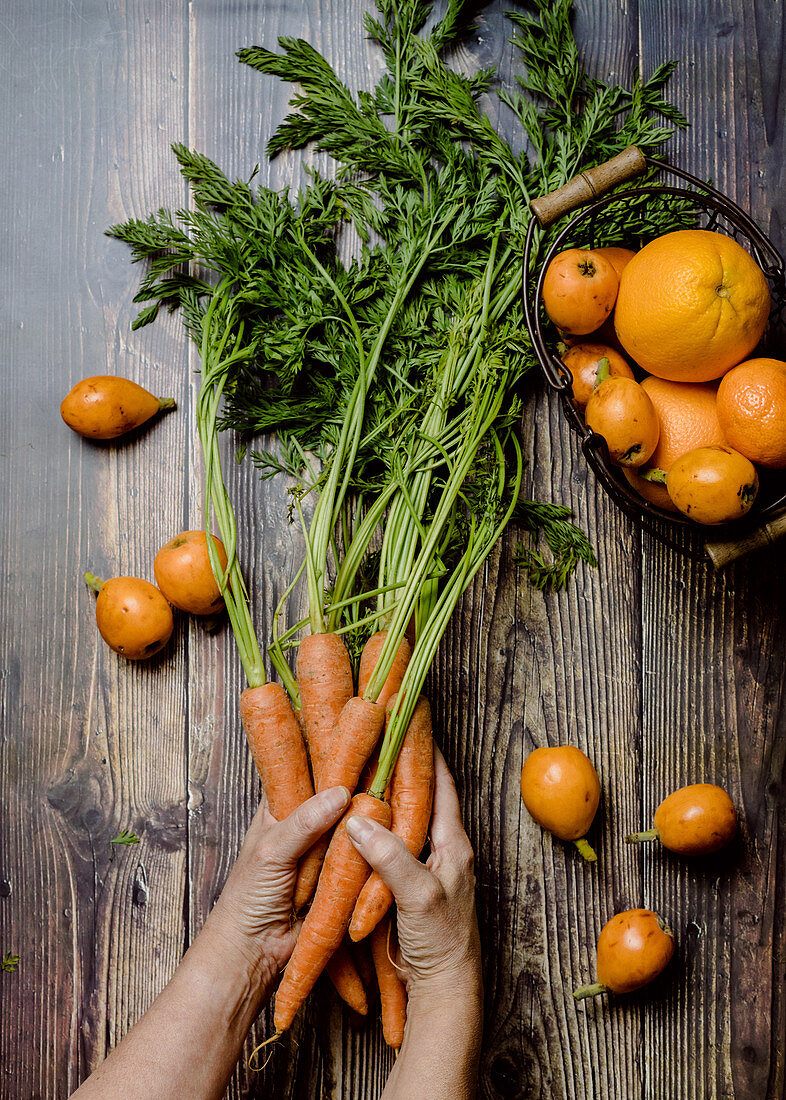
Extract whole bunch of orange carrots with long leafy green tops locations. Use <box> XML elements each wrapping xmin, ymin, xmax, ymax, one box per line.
<box><xmin>111</xmin><ymin>0</ymin><xmax>685</xmax><ymax>1046</ymax></box>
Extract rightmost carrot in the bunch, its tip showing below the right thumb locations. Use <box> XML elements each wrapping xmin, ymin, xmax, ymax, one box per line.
<box><xmin>350</xmin><ymin>695</ymin><xmax>434</xmax><ymax>941</ymax></box>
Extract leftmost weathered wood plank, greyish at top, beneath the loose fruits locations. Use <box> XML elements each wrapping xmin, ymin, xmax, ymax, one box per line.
<box><xmin>0</xmin><ymin>0</ymin><xmax>187</xmax><ymax>1097</ymax></box>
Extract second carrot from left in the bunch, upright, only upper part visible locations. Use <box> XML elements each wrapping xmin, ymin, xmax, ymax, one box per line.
<box><xmin>298</xmin><ymin>634</ymin><xmax>354</xmax><ymax>782</ymax></box>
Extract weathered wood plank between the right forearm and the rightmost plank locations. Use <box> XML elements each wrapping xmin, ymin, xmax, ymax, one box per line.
<box><xmin>432</xmin><ymin>4</ymin><xmax>641</xmax><ymax>1098</ymax></box>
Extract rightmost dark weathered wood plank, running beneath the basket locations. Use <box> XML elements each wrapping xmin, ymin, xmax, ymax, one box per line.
<box><xmin>640</xmin><ymin>0</ymin><xmax>786</xmax><ymax>1100</ymax></box>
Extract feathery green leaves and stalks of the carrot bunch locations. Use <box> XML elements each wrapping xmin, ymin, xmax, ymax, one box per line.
<box><xmin>110</xmin><ymin>0</ymin><xmax>687</xmax><ymax>794</ymax></box>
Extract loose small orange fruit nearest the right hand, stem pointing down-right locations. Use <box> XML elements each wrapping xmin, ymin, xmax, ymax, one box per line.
<box><xmin>521</xmin><ymin>745</ymin><xmax>600</xmax><ymax>862</ymax></box>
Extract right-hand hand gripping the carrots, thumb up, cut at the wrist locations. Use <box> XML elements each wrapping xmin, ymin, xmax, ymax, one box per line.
<box><xmin>346</xmin><ymin>747</ymin><xmax>483</xmax><ymax>1003</ymax></box>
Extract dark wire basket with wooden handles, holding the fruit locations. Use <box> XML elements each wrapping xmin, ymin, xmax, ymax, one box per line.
<box><xmin>523</xmin><ymin>146</ymin><xmax>786</xmax><ymax>567</ymax></box>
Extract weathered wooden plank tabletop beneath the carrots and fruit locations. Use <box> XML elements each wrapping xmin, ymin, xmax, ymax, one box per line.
<box><xmin>0</xmin><ymin>0</ymin><xmax>786</xmax><ymax>1100</ymax></box>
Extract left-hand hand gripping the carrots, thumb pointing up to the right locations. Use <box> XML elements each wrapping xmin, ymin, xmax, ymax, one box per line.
<box><xmin>204</xmin><ymin>787</ymin><xmax>350</xmax><ymax>983</ymax></box>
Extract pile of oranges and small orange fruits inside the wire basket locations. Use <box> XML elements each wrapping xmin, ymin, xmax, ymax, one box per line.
<box><xmin>543</xmin><ymin>229</ymin><xmax>786</xmax><ymax>524</ymax></box>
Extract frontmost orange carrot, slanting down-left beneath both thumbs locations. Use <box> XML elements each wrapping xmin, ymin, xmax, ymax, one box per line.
<box><xmin>274</xmin><ymin>794</ymin><xmax>390</xmax><ymax>1034</ymax></box>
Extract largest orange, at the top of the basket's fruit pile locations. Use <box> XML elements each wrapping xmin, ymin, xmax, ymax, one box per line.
<box><xmin>615</xmin><ymin>229</ymin><xmax>770</xmax><ymax>382</ymax></box>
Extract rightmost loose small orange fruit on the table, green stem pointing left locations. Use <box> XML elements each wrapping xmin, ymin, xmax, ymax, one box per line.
<box><xmin>626</xmin><ymin>783</ymin><xmax>737</xmax><ymax>856</ymax></box>
